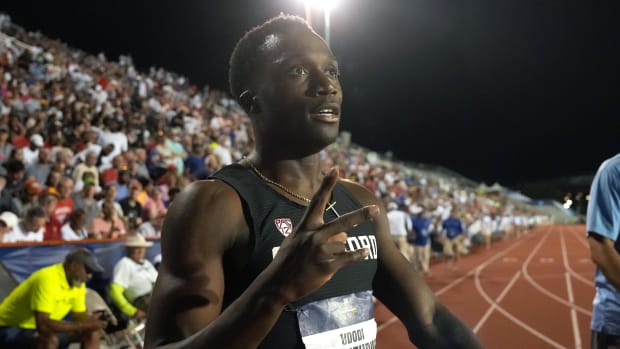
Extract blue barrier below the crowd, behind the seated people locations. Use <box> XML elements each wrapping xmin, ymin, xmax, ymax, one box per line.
<box><xmin>0</xmin><ymin>239</ymin><xmax>161</xmax><ymax>283</ymax></box>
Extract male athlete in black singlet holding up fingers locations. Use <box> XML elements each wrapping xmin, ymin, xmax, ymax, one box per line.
<box><xmin>145</xmin><ymin>16</ymin><xmax>482</xmax><ymax>349</ymax></box>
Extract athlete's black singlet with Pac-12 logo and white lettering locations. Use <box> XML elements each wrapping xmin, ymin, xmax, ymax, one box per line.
<box><xmin>213</xmin><ymin>164</ymin><xmax>377</xmax><ymax>349</ymax></box>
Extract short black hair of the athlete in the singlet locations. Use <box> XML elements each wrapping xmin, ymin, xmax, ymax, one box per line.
<box><xmin>228</xmin><ymin>13</ymin><xmax>318</xmax><ymax>100</ymax></box>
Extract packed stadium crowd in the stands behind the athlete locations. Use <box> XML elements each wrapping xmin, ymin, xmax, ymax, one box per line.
<box><xmin>0</xmin><ymin>16</ymin><xmax>534</xmax><ymax>251</ymax></box>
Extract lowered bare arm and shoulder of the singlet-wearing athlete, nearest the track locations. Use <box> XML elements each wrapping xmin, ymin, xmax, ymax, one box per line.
<box><xmin>343</xmin><ymin>181</ymin><xmax>483</xmax><ymax>349</ymax></box>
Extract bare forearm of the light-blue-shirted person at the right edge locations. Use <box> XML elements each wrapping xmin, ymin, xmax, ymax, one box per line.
<box><xmin>588</xmin><ymin>232</ymin><xmax>620</xmax><ymax>290</ymax></box>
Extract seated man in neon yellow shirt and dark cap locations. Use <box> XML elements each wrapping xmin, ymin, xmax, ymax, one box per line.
<box><xmin>0</xmin><ymin>248</ymin><xmax>107</xmax><ymax>349</ymax></box>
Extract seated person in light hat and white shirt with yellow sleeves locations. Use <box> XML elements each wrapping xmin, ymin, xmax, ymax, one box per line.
<box><xmin>109</xmin><ymin>234</ymin><xmax>157</xmax><ymax>320</ymax></box>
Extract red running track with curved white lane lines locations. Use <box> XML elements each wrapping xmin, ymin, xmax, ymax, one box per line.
<box><xmin>375</xmin><ymin>225</ymin><xmax>594</xmax><ymax>349</ymax></box>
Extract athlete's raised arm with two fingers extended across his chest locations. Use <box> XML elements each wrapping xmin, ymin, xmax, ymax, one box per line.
<box><xmin>145</xmin><ymin>174</ymin><xmax>376</xmax><ymax>349</ymax></box>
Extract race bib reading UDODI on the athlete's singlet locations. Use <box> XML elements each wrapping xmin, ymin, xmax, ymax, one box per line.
<box><xmin>297</xmin><ymin>291</ymin><xmax>377</xmax><ymax>349</ymax></box>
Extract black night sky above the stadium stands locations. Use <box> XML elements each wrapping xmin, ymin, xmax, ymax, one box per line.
<box><xmin>0</xmin><ymin>0</ymin><xmax>620</xmax><ymax>186</ymax></box>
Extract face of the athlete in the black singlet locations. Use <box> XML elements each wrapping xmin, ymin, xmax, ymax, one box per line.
<box><xmin>251</xmin><ymin>29</ymin><xmax>342</xmax><ymax>153</ymax></box>
